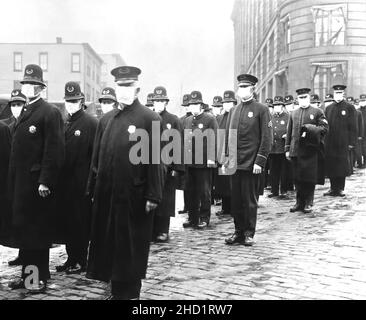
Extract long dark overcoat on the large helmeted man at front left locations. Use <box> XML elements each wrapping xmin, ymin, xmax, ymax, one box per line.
<box><xmin>9</xmin><ymin>99</ymin><xmax>65</xmax><ymax>249</ymax></box>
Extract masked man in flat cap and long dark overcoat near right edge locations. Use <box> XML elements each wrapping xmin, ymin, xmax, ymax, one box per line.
<box><xmin>324</xmin><ymin>85</ymin><xmax>357</xmax><ymax>197</ymax></box>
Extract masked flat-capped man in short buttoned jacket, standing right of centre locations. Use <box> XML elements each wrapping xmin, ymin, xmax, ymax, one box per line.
<box><xmin>225</xmin><ymin>74</ymin><xmax>272</xmax><ymax>246</ymax></box>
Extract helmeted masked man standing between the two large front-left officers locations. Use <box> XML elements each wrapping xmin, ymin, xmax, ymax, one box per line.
<box><xmin>55</xmin><ymin>81</ymin><xmax>97</xmax><ymax>274</ymax></box>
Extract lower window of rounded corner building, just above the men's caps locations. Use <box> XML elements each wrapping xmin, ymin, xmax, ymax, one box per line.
<box><xmin>312</xmin><ymin>61</ymin><xmax>347</xmax><ymax>99</ymax></box>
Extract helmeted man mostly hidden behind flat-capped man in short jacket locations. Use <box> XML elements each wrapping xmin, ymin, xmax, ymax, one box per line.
<box><xmin>215</xmin><ymin>90</ymin><xmax>238</xmax><ymax>216</ymax></box>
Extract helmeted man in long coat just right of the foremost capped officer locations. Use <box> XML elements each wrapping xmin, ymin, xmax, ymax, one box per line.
<box><xmin>152</xmin><ymin>86</ymin><xmax>184</xmax><ymax>242</ymax></box>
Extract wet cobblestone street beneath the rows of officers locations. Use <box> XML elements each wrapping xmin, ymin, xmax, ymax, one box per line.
<box><xmin>0</xmin><ymin>170</ymin><xmax>366</xmax><ymax>300</ymax></box>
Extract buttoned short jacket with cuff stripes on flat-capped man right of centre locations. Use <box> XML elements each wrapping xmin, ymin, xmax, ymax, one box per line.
<box><xmin>227</xmin><ymin>100</ymin><xmax>272</xmax><ymax>171</ymax></box>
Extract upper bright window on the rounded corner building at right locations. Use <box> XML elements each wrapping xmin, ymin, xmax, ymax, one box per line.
<box><xmin>313</xmin><ymin>6</ymin><xmax>346</xmax><ymax>47</ymax></box>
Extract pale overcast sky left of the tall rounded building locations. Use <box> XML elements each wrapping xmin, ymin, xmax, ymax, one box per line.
<box><xmin>0</xmin><ymin>0</ymin><xmax>234</xmax><ymax>114</ymax></box>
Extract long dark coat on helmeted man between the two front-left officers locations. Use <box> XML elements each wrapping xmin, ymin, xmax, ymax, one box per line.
<box><xmin>55</xmin><ymin>110</ymin><xmax>97</xmax><ymax>242</ymax></box>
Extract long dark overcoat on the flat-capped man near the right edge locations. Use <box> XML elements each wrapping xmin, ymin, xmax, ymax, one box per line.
<box><xmin>325</xmin><ymin>100</ymin><xmax>357</xmax><ymax>177</ymax></box>
